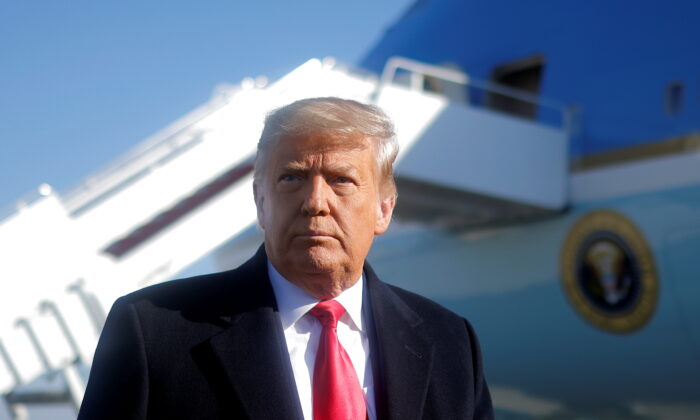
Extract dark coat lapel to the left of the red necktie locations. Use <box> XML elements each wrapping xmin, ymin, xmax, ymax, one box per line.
<box><xmin>201</xmin><ymin>247</ymin><xmax>303</xmax><ymax>419</ymax></box>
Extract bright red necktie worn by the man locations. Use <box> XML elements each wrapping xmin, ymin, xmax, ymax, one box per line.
<box><xmin>309</xmin><ymin>300</ymin><xmax>367</xmax><ymax>420</ymax></box>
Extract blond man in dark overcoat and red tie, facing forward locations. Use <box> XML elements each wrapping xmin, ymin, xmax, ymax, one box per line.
<box><xmin>79</xmin><ymin>98</ymin><xmax>493</xmax><ymax>420</ymax></box>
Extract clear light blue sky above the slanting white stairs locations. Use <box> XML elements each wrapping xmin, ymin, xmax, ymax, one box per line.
<box><xmin>0</xmin><ymin>0</ymin><xmax>412</xmax><ymax>209</ymax></box>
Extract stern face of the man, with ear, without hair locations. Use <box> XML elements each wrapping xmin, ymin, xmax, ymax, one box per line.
<box><xmin>254</xmin><ymin>134</ymin><xmax>395</xmax><ymax>299</ymax></box>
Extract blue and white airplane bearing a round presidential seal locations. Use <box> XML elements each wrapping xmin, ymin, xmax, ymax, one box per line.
<box><xmin>361</xmin><ymin>0</ymin><xmax>700</xmax><ymax>418</ymax></box>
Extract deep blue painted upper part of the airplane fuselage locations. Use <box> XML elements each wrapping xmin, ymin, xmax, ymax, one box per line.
<box><xmin>360</xmin><ymin>0</ymin><xmax>700</xmax><ymax>157</ymax></box>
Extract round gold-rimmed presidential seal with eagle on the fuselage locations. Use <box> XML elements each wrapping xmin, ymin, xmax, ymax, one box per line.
<box><xmin>561</xmin><ymin>210</ymin><xmax>659</xmax><ymax>333</ymax></box>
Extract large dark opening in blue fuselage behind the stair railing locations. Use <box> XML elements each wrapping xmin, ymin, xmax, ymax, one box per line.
<box><xmin>487</xmin><ymin>55</ymin><xmax>544</xmax><ymax>119</ymax></box>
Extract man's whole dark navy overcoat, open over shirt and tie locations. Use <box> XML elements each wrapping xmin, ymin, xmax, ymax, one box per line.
<box><xmin>78</xmin><ymin>247</ymin><xmax>493</xmax><ymax>420</ymax></box>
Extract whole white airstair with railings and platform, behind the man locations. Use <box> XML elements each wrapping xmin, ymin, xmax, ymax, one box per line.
<box><xmin>0</xmin><ymin>58</ymin><xmax>570</xmax><ymax>419</ymax></box>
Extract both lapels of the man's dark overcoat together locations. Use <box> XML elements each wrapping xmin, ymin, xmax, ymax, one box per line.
<box><xmin>201</xmin><ymin>246</ymin><xmax>433</xmax><ymax>420</ymax></box>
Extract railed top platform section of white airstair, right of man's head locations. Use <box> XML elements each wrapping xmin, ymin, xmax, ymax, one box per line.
<box><xmin>376</xmin><ymin>57</ymin><xmax>573</xmax><ymax>230</ymax></box>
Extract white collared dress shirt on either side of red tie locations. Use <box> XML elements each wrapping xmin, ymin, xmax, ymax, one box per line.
<box><xmin>267</xmin><ymin>261</ymin><xmax>377</xmax><ymax>420</ymax></box>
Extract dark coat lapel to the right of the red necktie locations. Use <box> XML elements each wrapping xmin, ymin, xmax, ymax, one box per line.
<box><xmin>365</xmin><ymin>264</ymin><xmax>433</xmax><ymax>420</ymax></box>
